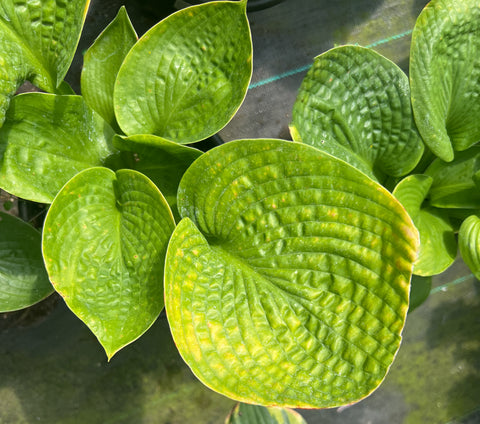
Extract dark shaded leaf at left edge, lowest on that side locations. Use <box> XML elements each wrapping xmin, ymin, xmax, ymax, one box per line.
<box><xmin>0</xmin><ymin>212</ymin><xmax>53</xmax><ymax>312</ymax></box>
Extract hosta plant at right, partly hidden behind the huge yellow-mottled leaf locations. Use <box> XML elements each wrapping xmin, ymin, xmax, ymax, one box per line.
<box><xmin>291</xmin><ymin>0</ymin><xmax>480</xmax><ymax>306</ymax></box>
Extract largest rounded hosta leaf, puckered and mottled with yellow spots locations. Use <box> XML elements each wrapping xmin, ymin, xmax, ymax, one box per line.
<box><xmin>165</xmin><ymin>140</ymin><xmax>417</xmax><ymax>407</ymax></box>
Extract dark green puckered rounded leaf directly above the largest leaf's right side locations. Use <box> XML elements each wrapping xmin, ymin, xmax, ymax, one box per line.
<box><xmin>292</xmin><ymin>46</ymin><xmax>424</xmax><ymax>182</ymax></box>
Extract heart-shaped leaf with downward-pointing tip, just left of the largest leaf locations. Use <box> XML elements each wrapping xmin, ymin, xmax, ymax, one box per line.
<box><xmin>43</xmin><ymin>168</ymin><xmax>174</xmax><ymax>358</ymax></box>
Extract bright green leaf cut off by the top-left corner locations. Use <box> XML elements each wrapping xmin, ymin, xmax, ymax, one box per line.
<box><xmin>0</xmin><ymin>0</ymin><xmax>90</xmax><ymax>125</ymax></box>
